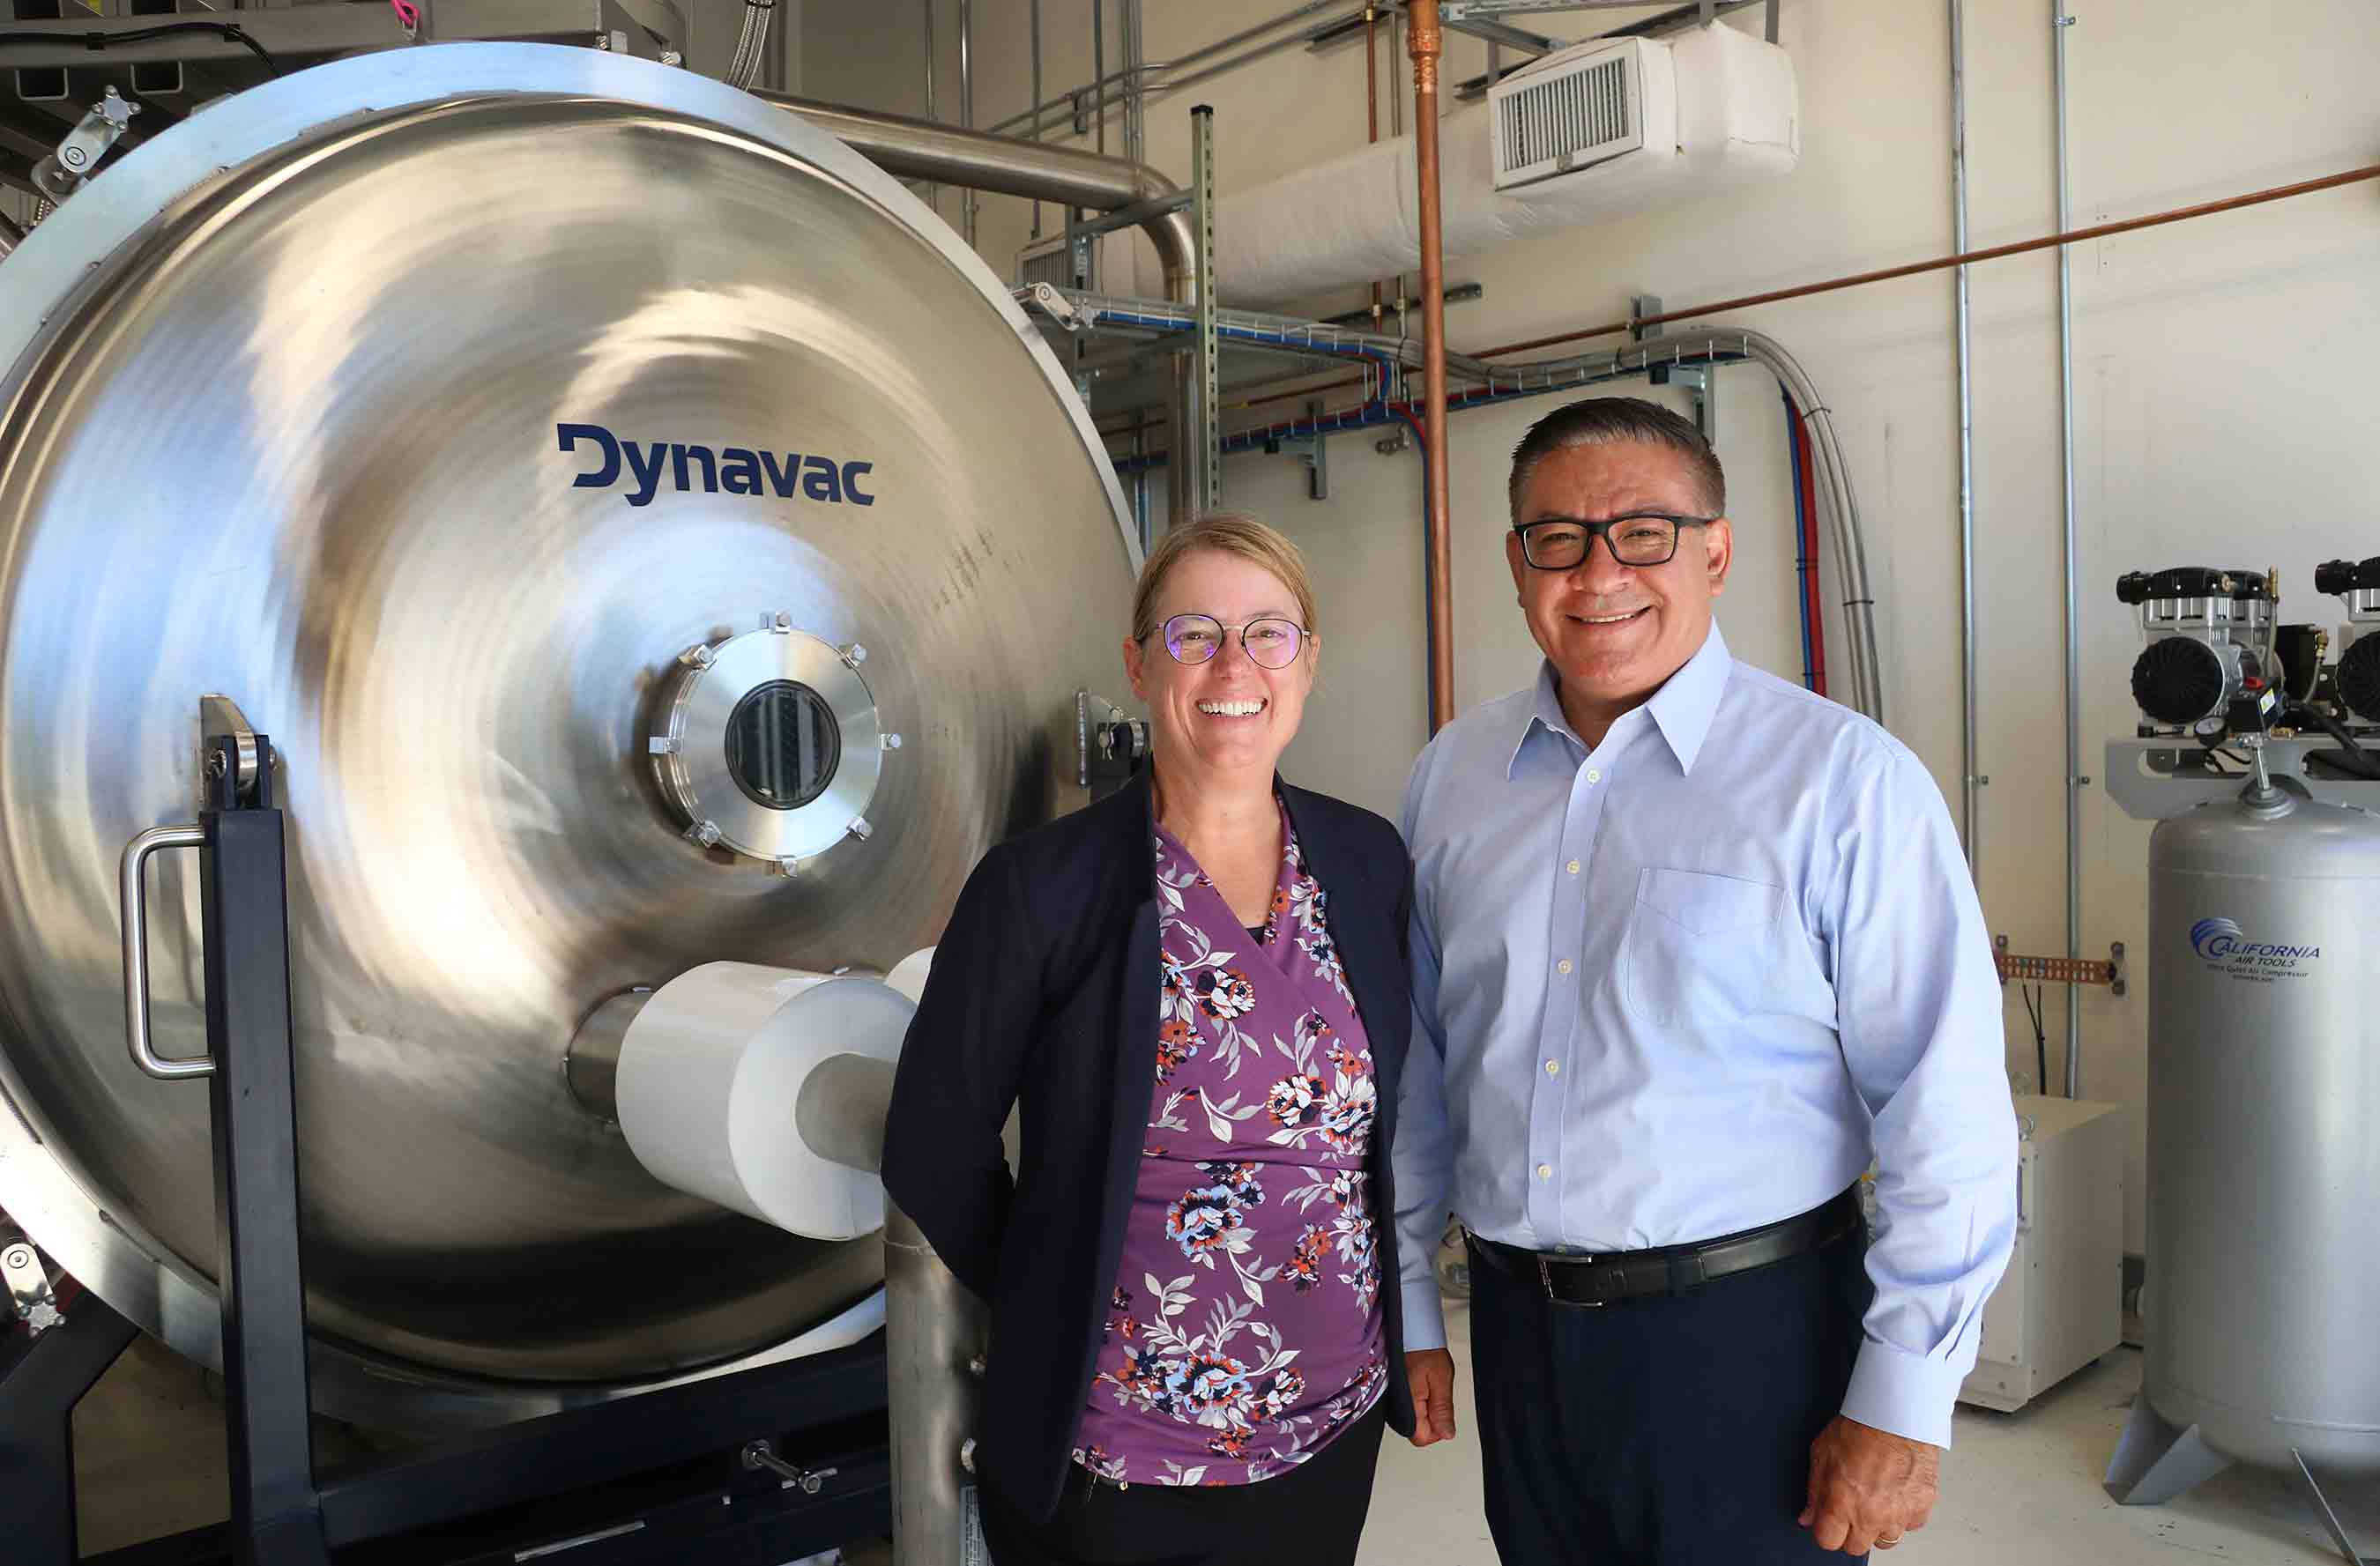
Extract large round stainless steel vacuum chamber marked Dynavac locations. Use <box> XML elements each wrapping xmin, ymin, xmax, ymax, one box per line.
<box><xmin>0</xmin><ymin>45</ymin><xmax>1138</xmax><ymax>1428</ymax></box>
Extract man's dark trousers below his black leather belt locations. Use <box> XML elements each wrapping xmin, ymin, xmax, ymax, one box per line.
<box><xmin>1471</xmin><ymin>1228</ymin><xmax>1873</xmax><ymax>1566</ymax></box>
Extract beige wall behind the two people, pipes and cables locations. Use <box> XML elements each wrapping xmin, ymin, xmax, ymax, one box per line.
<box><xmin>805</xmin><ymin>0</ymin><xmax>2380</xmax><ymax>1247</ymax></box>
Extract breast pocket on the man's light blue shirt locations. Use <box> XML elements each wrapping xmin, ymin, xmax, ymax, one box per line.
<box><xmin>1621</xmin><ymin>869</ymin><xmax>1785</xmax><ymax>1028</ymax></box>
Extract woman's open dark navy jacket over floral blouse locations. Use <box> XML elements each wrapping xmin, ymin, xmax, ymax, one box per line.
<box><xmin>883</xmin><ymin>776</ymin><xmax>1414</xmax><ymax>1518</ymax></box>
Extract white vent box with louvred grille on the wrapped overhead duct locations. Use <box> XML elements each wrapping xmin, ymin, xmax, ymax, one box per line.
<box><xmin>1488</xmin><ymin>38</ymin><xmax>1678</xmax><ymax>190</ymax></box>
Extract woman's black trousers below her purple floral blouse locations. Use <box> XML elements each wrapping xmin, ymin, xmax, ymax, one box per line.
<box><xmin>980</xmin><ymin>1397</ymin><xmax>1387</xmax><ymax>1566</ymax></box>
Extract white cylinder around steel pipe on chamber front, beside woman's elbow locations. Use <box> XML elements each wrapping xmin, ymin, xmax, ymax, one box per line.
<box><xmin>616</xmin><ymin>961</ymin><xmax>917</xmax><ymax>1240</ymax></box>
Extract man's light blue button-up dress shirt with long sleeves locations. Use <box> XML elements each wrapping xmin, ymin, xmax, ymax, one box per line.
<box><xmin>1395</xmin><ymin>626</ymin><xmax>2016</xmax><ymax>1447</ymax></box>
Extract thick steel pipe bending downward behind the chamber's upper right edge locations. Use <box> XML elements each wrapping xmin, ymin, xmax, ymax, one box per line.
<box><xmin>755</xmin><ymin>93</ymin><xmax>1209</xmax><ymax>519</ymax></box>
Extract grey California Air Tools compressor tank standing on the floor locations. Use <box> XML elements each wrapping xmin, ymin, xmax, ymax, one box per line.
<box><xmin>2109</xmin><ymin>790</ymin><xmax>2380</xmax><ymax>1502</ymax></box>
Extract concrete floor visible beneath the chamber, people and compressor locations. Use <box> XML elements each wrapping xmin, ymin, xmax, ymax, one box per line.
<box><xmin>60</xmin><ymin>1302</ymin><xmax>2380</xmax><ymax>1566</ymax></box>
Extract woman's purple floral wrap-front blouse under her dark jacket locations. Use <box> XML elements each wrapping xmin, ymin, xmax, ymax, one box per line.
<box><xmin>1074</xmin><ymin>809</ymin><xmax>1387</xmax><ymax>1485</ymax></box>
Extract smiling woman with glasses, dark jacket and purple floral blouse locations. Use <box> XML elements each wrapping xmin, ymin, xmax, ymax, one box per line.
<box><xmin>883</xmin><ymin>514</ymin><xmax>1411</xmax><ymax>1566</ymax></box>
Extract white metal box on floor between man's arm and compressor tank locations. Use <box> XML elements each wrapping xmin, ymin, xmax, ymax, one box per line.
<box><xmin>1959</xmin><ymin>1095</ymin><xmax>2125</xmax><ymax>1414</ymax></box>
